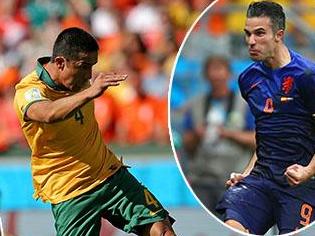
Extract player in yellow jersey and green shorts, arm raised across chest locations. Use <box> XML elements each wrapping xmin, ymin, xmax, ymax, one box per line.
<box><xmin>14</xmin><ymin>28</ymin><xmax>175</xmax><ymax>236</ymax></box>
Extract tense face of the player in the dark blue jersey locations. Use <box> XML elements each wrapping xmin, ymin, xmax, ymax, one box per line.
<box><xmin>244</xmin><ymin>17</ymin><xmax>277</xmax><ymax>61</ymax></box>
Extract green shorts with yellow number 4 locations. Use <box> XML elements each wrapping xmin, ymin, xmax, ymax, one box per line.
<box><xmin>52</xmin><ymin>167</ymin><xmax>173</xmax><ymax>236</ymax></box>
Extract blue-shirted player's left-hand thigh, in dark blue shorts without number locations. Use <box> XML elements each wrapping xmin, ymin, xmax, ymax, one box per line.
<box><xmin>216</xmin><ymin>175</ymin><xmax>275</xmax><ymax>235</ymax></box>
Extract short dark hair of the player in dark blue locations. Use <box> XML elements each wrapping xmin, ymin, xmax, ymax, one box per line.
<box><xmin>246</xmin><ymin>1</ymin><xmax>285</xmax><ymax>33</ymax></box>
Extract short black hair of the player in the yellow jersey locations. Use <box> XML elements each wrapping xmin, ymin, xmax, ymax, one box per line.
<box><xmin>52</xmin><ymin>27</ymin><xmax>99</xmax><ymax>60</ymax></box>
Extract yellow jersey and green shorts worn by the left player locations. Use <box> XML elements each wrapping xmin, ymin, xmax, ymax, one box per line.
<box><xmin>14</xmin><ymin>57</ymin><xmax>173</xmax><ymax>236</ymax></box>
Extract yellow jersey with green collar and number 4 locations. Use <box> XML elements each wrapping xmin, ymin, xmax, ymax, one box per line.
<box><xmin>14</xmin><ymin>57</ymin><xmax>122</xmax><ymax>204</ymax></box>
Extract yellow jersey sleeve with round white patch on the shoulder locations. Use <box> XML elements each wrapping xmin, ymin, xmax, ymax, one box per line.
<box><xmin>15</xmin><ymin>85</ymin><xmax>49</xmax><ymax>120</ymax></box>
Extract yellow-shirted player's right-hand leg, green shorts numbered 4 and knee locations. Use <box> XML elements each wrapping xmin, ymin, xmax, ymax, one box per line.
<box><xmin>101</xmin><ymin>167</ymin><xmax>175</xmax><ymax>236</ymax></box>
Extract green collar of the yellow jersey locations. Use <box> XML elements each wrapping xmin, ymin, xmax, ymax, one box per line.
<box><xmin>36</xmin><ymin>57</ymin><xmax>65</xmax><ymax>91</ymax></box>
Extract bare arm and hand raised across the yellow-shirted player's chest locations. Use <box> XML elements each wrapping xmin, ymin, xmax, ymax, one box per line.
<box><xmin>25</xmin><ymin>73</ymin><xmax>127</xmax><ymax>123</ymax></box>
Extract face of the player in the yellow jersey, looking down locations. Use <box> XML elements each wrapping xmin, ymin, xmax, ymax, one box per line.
<box><xmin>62</xmin><ymin>52</ymin><xmax>97</xmax><ymax>92</ymax></box>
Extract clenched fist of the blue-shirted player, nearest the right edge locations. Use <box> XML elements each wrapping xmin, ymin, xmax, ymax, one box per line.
<box><xmin>284</xmin><ymin>164</ymin><xmax>313</xmax><ymax>186</ymax></box>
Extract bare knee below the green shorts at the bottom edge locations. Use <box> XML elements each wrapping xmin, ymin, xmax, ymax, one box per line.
<box><xmin>139</xmin><ymin>218</ymin><xmax>176</xmax><ymax>236</ymax></box>
